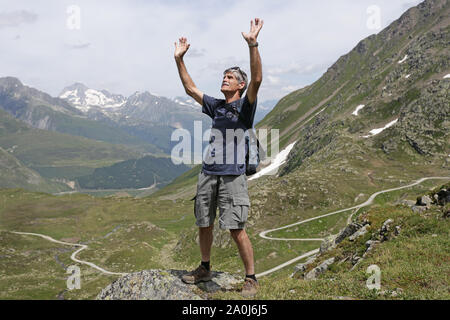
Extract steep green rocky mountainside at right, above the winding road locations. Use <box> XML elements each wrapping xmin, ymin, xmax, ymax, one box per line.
<box><xmin>258</xmin><ymin>0</ymin><xmax>450</xmax><ymax>174</ymax></box>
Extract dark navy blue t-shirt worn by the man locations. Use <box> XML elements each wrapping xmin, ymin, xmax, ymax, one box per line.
<box><xmin>202</xmin><ymin>94</ymin><xmax>257</xmax><ymax>175</ymax></box>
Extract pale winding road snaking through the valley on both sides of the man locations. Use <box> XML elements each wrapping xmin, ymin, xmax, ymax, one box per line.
<box><xmin>11</xmin><ymin>177</ymin><xmax>450</xmax><ymax>277</ymax></box>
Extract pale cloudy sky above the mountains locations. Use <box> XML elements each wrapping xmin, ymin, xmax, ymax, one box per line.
<box><xmin>0</xmin><ymin>0</ymin><xmax>421</xmax><ymax>101</ymax></box>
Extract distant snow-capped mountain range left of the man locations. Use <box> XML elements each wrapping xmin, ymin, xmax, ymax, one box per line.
<box><xmin>59</xmin><ymin>83</ymin><xmax>211</xmax><ymax>154</ymax></box>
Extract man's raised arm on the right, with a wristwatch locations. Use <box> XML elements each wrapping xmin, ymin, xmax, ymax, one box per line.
<box><xmin>242</xmin><ymin>18</ymin><xmax>264</xmax><ymax>104</ymax></box>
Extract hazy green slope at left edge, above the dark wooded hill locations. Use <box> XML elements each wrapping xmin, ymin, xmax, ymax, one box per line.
<box><xmin>0</xmin><ymin>109</ymin><xmax>141</xmax><ymax>180</ymax></box>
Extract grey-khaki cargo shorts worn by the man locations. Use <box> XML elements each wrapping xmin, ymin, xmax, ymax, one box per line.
<box><xmin>194</xmin><ymin>171</ymin><xmax>250</xmax><ymax>230</ymax></box>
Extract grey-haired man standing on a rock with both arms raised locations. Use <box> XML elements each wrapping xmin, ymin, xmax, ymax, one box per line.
<box><xmin>174</xmin><ymin>18</ymin><xmax>264</xmax><ymax>297</ymax></box>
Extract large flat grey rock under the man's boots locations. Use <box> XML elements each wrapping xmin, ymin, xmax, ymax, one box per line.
<box><xmin>96</xmin><ymin>270</ymin><xmax>242</xmax><ymax>300</ymax></box>
